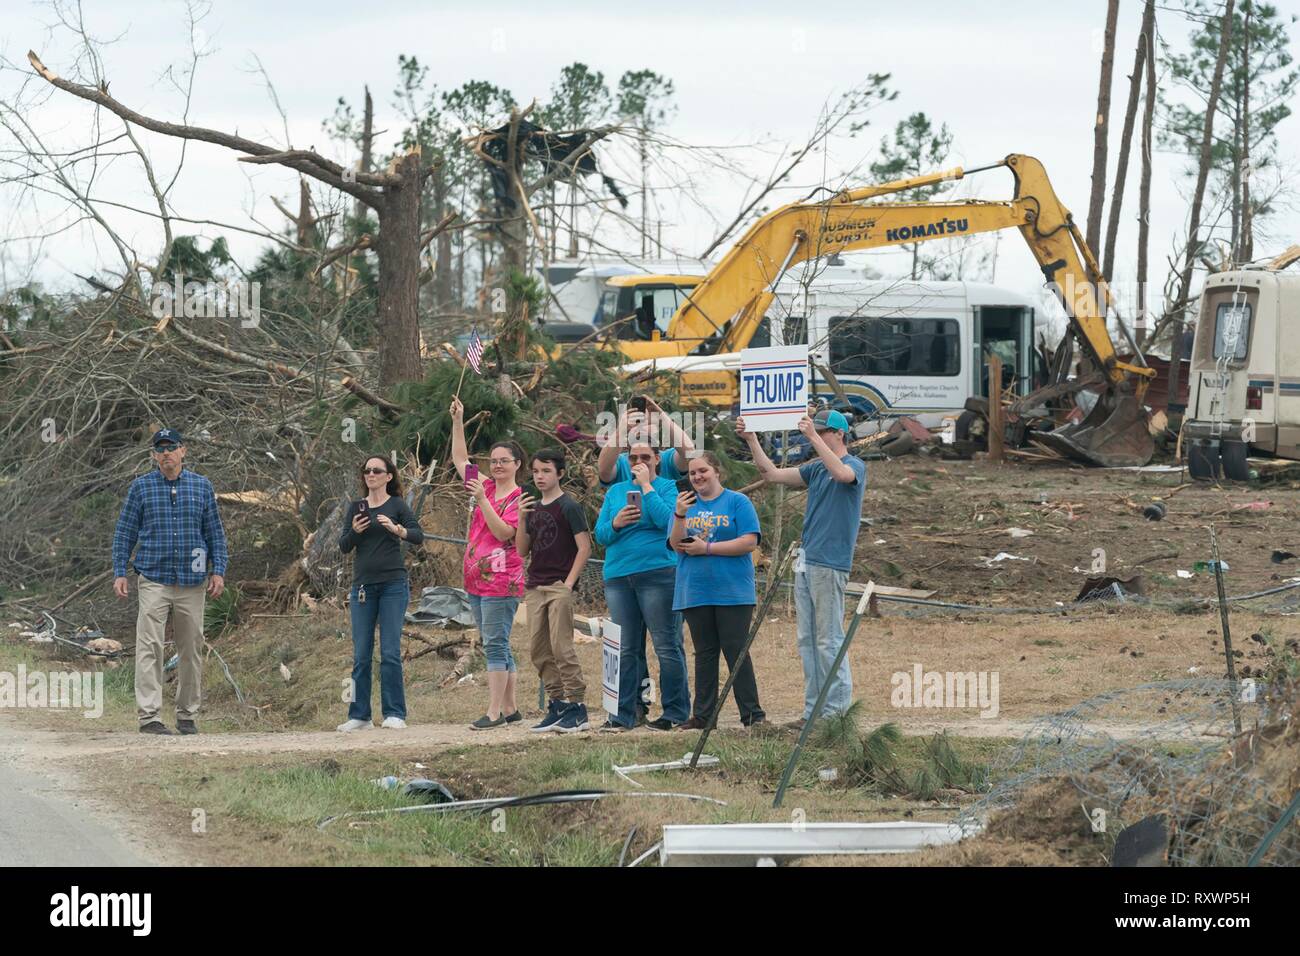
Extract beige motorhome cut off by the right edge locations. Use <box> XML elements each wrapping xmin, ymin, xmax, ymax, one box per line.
<box><xmin>1183</xmin><ymin>268</ymin><xmax>1300</xmax><ymax>480</ymax></box>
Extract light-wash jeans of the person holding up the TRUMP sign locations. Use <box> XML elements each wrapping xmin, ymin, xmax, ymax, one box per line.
<box><xmin>794</xmin><ymin>564</ymin><xmax>853</xmax><ymax>719</ymax></box>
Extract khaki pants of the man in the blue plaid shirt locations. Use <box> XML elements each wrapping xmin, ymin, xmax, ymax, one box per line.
<box><xmin>135</xmin><ymin>578</ymin><xmax>207</xmax><ymax>726</ymax></box>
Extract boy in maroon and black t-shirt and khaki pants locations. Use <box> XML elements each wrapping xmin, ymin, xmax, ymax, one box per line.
<box><xmin>515</xmin><ymin>449</ymin><xmax>592</xmax><ymax>734</ymax></box>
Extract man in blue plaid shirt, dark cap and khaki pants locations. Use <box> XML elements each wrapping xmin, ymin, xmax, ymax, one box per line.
<box><xmin>113</xmin><ymin>428</ymin><xmax>228</xmax><ymax>734</ymax></box>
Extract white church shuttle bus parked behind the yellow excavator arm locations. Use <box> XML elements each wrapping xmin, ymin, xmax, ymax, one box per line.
<box><xmin>624</xmin><ymin>280</ymin><xmax>1047</xmax><ymax>434</ymax></box>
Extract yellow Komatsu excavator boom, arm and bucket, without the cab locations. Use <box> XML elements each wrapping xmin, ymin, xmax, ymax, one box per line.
<box><xmin>619</xmin><ymin>153</ymin><xmax>1156</xmax><ymax>466</ymax></box>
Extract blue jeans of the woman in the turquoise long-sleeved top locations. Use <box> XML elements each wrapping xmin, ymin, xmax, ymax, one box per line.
<box><xmin>605</xmin><ymin>567</ymin><xmax>690</xmax><ymax>727</ymax></box>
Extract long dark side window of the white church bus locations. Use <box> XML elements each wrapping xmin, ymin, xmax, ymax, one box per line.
<box><xmin>831</xmin><ymin>316</ymin><xmax>961</xmax><ymax>376</ymax></box>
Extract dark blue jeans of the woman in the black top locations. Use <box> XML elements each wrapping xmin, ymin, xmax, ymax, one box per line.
<box><xmin>347</xmin><ymin>578</ymin><xmax>411</xmax><ymax>721</ymax></box>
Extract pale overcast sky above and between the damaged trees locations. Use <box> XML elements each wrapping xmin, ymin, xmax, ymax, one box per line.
<box><xmin>0</xmin><ymin>0</ymin><xmax>1300</xmax><ymax>312</ymax></box>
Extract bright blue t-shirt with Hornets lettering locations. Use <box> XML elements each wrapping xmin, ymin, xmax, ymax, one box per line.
<box><xmin>668</xmin><ymin>488</ymin><xmax>762</xmax><ymax>611</ymax></box>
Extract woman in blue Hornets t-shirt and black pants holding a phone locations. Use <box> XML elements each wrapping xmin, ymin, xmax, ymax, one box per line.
<box><xmin>668</xmin><ymin>451</ymin><xmax>764</xmax><ymax>730</ymax></box>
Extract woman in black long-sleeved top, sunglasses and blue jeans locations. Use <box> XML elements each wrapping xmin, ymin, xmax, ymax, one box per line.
<box><xmin>338</xmin><ymin>455</ymin><xmax>424</xmax><ymax>734</ymax></box>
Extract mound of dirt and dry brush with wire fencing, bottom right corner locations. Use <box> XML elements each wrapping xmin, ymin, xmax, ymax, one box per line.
<box><xmin>958</xmin><ymin>680</ymin><xmax>1300</xmax><ymax>866</ymax></box>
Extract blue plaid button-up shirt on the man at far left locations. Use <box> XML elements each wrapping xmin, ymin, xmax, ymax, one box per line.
<box><xmin>113</xmin><ymin>468</ymin><xmax>228</xmax><ymax>588</ymax></box>
